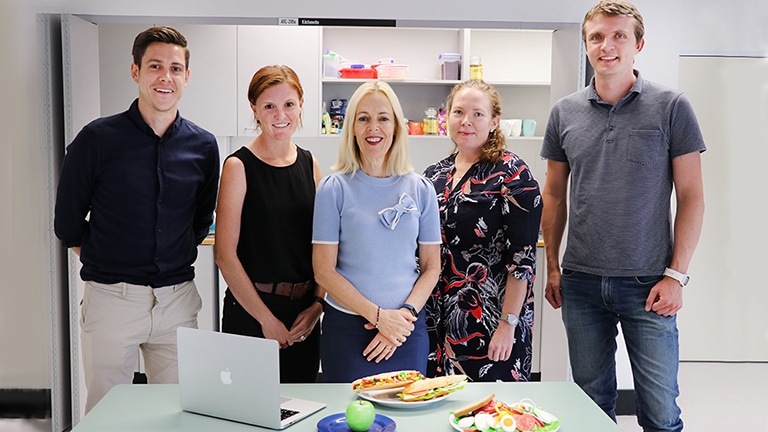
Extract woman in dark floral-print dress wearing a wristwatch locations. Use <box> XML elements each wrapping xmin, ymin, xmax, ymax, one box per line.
<box><xmin>424</xmin><ymin>80</ymin><xmax>542</xmax><ymax>381</ymax></box>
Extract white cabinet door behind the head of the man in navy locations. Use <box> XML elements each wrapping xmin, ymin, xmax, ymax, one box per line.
<box><xmin>99</xmin><ymin>23</ymin><xmax>237</xmax><ymax>136</ymax></box>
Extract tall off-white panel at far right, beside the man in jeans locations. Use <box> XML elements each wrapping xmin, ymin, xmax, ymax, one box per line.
<box><xmin>678</xmin><ymin>57</ymin><xmax>768</xmax><ymax>361</ymax></box>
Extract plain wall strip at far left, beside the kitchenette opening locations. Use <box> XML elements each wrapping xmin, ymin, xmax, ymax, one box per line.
<box><xmin>0</xmin><ymin>0</ymin><xmax>52</xmax><ymax>388</ymax></box>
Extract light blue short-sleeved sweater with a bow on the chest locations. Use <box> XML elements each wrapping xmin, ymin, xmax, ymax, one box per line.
<box><xmin>312</xmin><ymin>170</ymin><xmax>440</xmax><ymax>309</ymax></box>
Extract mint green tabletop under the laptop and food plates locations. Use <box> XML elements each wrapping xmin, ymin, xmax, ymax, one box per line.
<box><xmin>72</xmin><ymin>382</ymin><xmax>621</xmax><ymax>432</ymax></box>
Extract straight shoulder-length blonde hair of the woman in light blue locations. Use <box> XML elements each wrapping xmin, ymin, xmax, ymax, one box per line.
<box><xmin>331</xmin><ymin>81</ymin><xmax>413</xmax><ymax>175</ymax></box>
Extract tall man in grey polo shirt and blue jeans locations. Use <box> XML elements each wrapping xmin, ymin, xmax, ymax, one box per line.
<box><xmin>541</xmin><ymin>0</ymin><xmax>705</xmax><ymax>431</ymax></box>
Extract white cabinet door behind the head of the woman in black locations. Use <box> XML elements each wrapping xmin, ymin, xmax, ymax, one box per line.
<box><xmin>237</xmin><ymin>26</ymin><xmax>322</xmax><ymax>137</ymax></box>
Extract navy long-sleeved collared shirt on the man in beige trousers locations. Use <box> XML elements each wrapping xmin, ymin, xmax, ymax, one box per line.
<box><xmin>54</xmin><ymin>100</ymin><xmax>219</xmax><ymax>287</ymax></box>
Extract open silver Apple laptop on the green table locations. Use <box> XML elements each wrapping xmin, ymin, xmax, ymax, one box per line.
<box><xmin>177</xmin><ymin>327</ymin><xmax>325</xmax><ymax>429</ymax></box>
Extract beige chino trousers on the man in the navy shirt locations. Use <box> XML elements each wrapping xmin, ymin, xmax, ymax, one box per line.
<box><xmin>80</xmin><ymin>281</ymin><xmax>202</xmax><ymax>413</ymax></box>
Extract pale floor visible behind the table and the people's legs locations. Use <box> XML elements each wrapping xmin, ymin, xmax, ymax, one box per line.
<box><xmin>0</xmin><ymin>362</ymin><xmax>768</xmax><ymax>432</ymax></box>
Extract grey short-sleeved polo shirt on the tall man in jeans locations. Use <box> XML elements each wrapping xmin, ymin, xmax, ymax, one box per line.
<box><xmin>541</xmin><ymin>71</ymin><xmax>706</xmax><ymax>276</ymax></box>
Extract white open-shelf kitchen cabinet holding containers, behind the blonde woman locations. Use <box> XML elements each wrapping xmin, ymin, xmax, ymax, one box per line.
<box><xmin>318</xmin><ymin>27</ymin><xmax>554</xmax><ymax>139</ymax></box>
